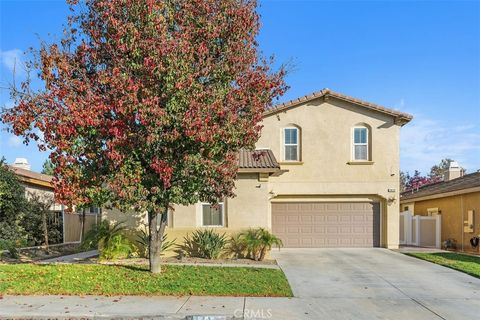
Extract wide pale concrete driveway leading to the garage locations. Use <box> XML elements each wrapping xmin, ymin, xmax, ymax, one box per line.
<box><xmin>270</xmin><ymin>249</ymin><xmax>480</xmax><ymax>319</ymax></box>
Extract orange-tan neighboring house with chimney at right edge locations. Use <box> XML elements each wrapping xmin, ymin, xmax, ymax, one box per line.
<box><xmin>400</xmin><ymin>162</ymin><xmax>480</xmax><ymax>251</ymax></box>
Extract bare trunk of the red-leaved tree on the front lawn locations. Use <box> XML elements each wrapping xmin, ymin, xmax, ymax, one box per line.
<box><xmin>148</xmin><ymin>206</ymin><xmax>168</xmax><ymax>273</ymax></box>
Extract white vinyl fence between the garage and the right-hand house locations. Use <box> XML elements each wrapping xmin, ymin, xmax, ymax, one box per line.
<box><xmin>400</xmin><ymin>211</ymin><xmax>442</xmax><ymax>249</ymax></box>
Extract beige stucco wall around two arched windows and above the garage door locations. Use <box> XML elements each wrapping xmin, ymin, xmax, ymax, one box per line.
<box><xmin>256</xmin><ymin>98</ymin><xmax>400</xmax><ymax>248</ymax></box>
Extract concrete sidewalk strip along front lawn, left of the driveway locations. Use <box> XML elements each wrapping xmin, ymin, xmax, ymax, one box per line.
<box><xmin>0</xmin><ymin>296</ymin><xmax>258</xmax><ymax>319</ymax></box>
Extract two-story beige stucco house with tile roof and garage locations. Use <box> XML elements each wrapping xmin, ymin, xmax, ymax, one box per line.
<box><xmin>103</xmin><ymin>89</ymin><xmax>412</xmax><ymax>248</ymax></box>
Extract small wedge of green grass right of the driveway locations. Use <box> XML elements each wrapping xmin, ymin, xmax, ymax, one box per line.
<box><xmin>407</xmin><ymin>252</ymin><xmax>480</xmax><ymax>278</ymax></box>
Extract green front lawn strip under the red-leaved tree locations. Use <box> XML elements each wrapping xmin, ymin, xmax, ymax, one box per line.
<box><xmin>0</xmin><ymin>264</ymin><xmax>292</xmax><ymax>297</ymax></box>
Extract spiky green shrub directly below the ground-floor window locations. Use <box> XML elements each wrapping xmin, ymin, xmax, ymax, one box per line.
<box><xmin>183</xmin><ymin>229</ymin><xmax>227</xmax><ymax>259</ymax></box>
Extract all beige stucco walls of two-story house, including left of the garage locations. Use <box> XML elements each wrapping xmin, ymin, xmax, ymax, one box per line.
<box><xmin>103</xmin><ymin>99</ymin><xmax>400</xmax><ymax>248</ymax></box>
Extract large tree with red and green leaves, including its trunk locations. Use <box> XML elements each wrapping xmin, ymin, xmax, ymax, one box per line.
<box><xmin>2</xmin><ymin>0</ymin><xmax>286</xmax><ymax>272</ymax></box>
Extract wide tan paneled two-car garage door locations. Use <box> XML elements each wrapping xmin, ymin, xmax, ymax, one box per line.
<box><xmin>272</xmin><ymin>202</ymin><xmax>380</xmax><ymax>248</ymax></box>
